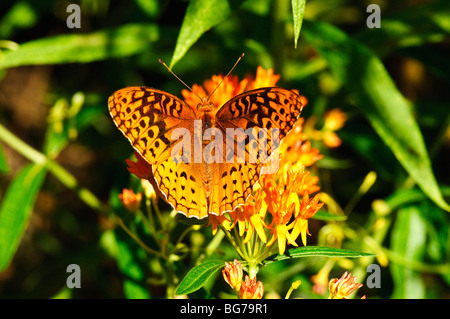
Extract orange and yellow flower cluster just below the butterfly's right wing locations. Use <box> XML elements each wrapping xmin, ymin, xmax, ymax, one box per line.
<box><xmin>209</xmin><ymin>169</ymin><xmax>323</xmax><ymax>254</ymax></box>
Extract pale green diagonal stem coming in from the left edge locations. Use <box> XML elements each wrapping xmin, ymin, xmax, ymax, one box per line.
<box><xmin>0</xmin><ymin>124</ymin><xmax>109</xmax><ymax>213</ymax></box>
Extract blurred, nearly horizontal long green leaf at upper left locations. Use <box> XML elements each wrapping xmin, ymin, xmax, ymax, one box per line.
<box><xmin>0</xmin><ymin>24</ymin><xmax>159</xmax><ymax>69</ymax></box>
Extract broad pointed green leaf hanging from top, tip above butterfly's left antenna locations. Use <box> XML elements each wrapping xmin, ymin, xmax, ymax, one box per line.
<box><xmin>170</xmin><ymin>0</ymin><xmax>240</xmax><ymax>68</ymax></box>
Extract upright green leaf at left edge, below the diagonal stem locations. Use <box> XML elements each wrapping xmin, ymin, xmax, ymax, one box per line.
<box><xmin>0</xmin><ymin>164</ymin><xmax>47</xmax><ymax>271</ymax></box>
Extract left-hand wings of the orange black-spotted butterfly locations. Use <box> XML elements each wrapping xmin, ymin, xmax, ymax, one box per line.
<box><xmin>108</xmin><ymin>87</ymin><xmax>207</xmax><ymax>217</ymax></box>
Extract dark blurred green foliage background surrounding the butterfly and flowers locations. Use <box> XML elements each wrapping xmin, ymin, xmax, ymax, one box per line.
<box><xmin>0</xmin><ymin>0</ymin><xmax>450</xmax><ymax>298</ymax></box>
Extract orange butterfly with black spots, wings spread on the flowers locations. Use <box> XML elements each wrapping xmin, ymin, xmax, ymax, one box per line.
<box><xmin>108</xmin><ymin>63</ymin><xmax>305</xmax><ymax>219</ymax></box>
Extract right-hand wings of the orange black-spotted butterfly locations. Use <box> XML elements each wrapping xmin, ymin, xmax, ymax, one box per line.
<box><xmin>209</xmin><ymin>87</ymin><xmax>304</xmax><ymax>214</ymax></box>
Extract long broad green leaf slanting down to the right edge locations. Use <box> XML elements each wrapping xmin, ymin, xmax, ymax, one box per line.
<box><xmin>304</xmin><ymin>21</ymin><xmax>450</xmax><ymax>215</ymax></box>
